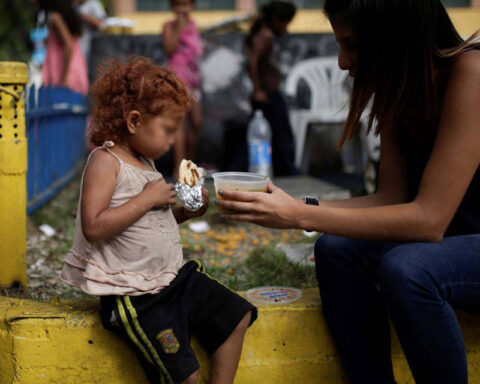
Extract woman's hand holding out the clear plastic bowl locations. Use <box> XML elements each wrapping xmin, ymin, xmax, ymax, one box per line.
<box><xmin>216</xmin><ymin>182</ymin><xmax>304</xmax><ymax>228</ymax></box>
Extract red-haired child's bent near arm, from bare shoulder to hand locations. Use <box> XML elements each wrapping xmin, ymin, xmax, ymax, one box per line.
<box><xmin>81</xmin><ymin>150</ymin><xmax>176</xmax><ymax>242</ymax></box>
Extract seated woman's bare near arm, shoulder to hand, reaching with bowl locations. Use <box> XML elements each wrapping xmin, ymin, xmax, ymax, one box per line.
<box><xmin>220</xmin><ymin>51</ymin><xmax>480</xmax><ymax>242</ymax></box>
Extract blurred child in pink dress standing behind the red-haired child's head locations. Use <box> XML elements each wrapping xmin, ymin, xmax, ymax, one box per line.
<box><xmin>162</xmin><ymin>0</ymin><xmax>203</xmax><ymax>176</ymax></box>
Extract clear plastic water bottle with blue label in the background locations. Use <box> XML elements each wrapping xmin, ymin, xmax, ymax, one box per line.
<box><xmin>247</xmin><ymin>110</ymin><xmax>273</xmax><ymax>177</ymax></box>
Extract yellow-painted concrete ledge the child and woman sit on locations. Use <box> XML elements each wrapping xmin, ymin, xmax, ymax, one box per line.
<box><xmin>0</xmin><ymin>289</ymin><xmax>480</xmax><ymax>384</ymax></box>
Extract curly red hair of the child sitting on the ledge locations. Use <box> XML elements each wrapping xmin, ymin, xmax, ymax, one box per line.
<box><xmin>89</xmin><ymin>57</ymin><xmax>195</xmax><ymax>145</ymax></box>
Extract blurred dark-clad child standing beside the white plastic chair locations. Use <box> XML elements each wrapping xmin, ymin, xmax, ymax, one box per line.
<box><xmin>245</xmin><ymin>0</ymin><xmax>297</xmax><ymax>176</ymax></box>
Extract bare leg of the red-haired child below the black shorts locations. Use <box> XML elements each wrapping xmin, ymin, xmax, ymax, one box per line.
<box><xmin>210</xmin><ymin>311</ymin><xmax>252</xmax><ymax>384</ymax></box>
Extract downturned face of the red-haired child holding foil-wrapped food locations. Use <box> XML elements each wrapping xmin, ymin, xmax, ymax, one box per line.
<box><xmin>130</xmin><ymin>114</ymin><xmax>185</xmax><ymax>159</ymax></box>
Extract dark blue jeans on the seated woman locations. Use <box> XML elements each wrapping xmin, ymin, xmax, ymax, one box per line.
<box><xmin>315</xmin><ymin>234</ymin><xmax>480</xmax><ymax>384</ymax></box>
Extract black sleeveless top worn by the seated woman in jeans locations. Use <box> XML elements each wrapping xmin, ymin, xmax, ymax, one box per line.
<box><xmin>397</xmin><ymin>46</ymin><xmax>480</xmax><ymax>236</ymax></box>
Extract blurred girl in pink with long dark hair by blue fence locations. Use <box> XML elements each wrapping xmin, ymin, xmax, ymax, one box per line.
<box><xmin>37</xmin><ymin>0</ymin><xmax>88</xmax><ymax>95</ymax></box>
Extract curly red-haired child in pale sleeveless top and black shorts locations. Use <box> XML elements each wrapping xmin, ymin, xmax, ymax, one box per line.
<box><xmin>61</xmin><ymin>58</ymin><xmax>256</xmax><ymax>384</ymax></box>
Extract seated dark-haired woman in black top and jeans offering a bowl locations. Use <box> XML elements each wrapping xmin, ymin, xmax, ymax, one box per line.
<box><xmin>218</xmin><ymin>0</ymin><xmax>480</xmax><ymax>384</ymax></box>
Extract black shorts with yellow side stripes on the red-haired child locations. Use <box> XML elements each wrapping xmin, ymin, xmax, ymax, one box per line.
<box><xmin>100</xmin><ymin>260</ymin><xmax>257</xmax><ymax>384</ymax></box>
